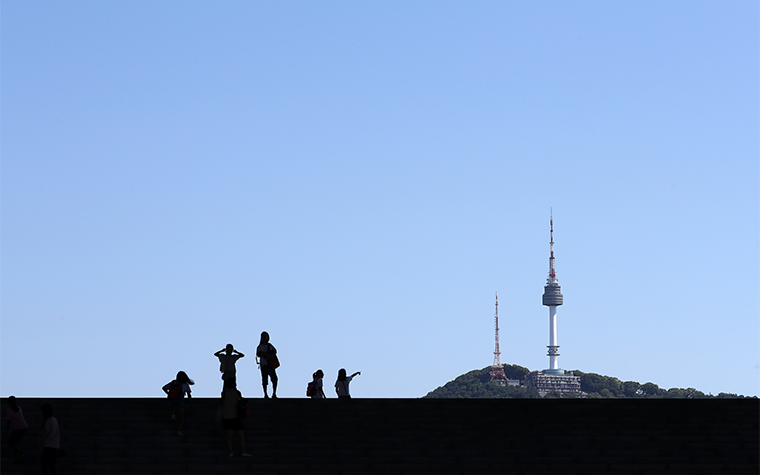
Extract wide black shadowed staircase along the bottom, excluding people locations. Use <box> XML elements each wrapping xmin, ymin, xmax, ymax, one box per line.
<box><xmin>2</xmin><ymin>398</ymin><xmax>760</xmax><ymax>475</ymax></box>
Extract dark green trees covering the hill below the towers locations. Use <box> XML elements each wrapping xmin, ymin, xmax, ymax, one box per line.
<box><xmin>424</xmin><ymin>364</ymin><xmax>756</xmax><ymax>399</ymax></box>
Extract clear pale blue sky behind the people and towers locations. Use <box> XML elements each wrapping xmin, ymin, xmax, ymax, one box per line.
<box><xmin>0</xmin><ymin>0</ymin><xmax>760</xmax><ymax>397</ymax></box>
